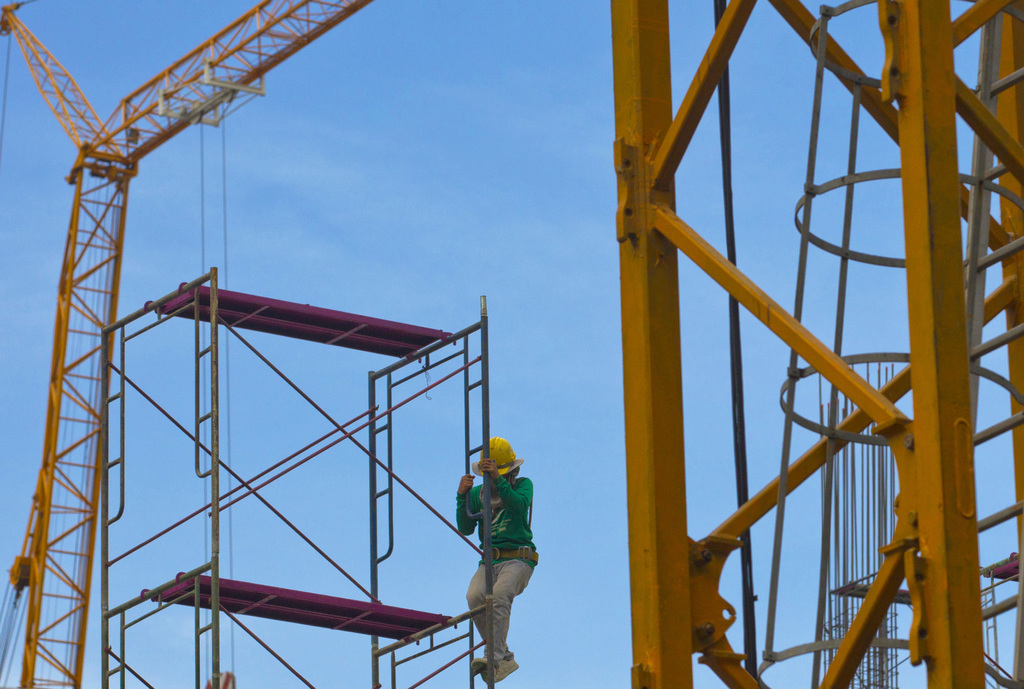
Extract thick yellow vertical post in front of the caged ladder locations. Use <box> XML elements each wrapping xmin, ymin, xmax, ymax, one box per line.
<box><xmin>892</xmin><ymin>0</ymin><xmax>985</xmax><ymax>689</ymax></box>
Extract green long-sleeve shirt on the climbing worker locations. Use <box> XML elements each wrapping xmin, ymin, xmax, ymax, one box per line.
<box><xmin>455</xmin><ymin>476</ymin><xmax>537</xmax><ymax>567</ymax></box>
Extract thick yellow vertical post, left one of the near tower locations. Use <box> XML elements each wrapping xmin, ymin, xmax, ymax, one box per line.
<box><xmin>611</xmin><ymin>0</ymin><xmax>694</xmax><ymax>689</ymax></box>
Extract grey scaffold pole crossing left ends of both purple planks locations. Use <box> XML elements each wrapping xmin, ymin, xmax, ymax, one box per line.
<box><xmin>207</xmin><ymin>268</ymin><xmax>220</xmax><ymax>689</ymax></box>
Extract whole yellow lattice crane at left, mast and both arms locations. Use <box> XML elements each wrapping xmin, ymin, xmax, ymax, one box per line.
<box><xmin>0</xmin><ymin>0</ymin><xmax>371</xmax><ymax>688</ymax></box>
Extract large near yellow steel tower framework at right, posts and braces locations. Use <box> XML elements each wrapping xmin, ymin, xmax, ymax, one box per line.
<box><xmin>611</xmin><ymin>0</ymin><xmax>1024</xmax><ymax>689</ymax></box>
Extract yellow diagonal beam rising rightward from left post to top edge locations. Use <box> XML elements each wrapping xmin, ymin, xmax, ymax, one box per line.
<box><xmin>651</xmin><ymin>0</ymin><xmax>756</xmax><ymax>189</ymax></box>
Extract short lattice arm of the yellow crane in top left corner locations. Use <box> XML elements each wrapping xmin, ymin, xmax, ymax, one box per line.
<box><xmin>0</xmin><ymin>4</ymin><xmax>108</xmax><ymax>147</ymax></box>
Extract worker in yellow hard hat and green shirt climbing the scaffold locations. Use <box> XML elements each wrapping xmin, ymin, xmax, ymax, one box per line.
<box><xmin>456</xmin><ymin>437</ymin><xmax>538</xmax><ymax>682</ymax></box>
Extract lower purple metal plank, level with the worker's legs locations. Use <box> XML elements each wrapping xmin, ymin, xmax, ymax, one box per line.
<box><xmin>155</xmin><ymin>574</ymin><xmax>450</xmax><ymax>639</ymax></box>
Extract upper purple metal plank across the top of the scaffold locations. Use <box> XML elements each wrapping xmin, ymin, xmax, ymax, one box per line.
<box><xmin>160</xmin><ymin>287</ymin><xmax>452</xmax><ymax>356</ymax></box>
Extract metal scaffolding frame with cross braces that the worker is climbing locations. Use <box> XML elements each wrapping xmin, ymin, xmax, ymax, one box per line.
<box><xmin>100</xmin><ymin>268</ymin><xmax>494</xmax><ymax>689</ymax></box>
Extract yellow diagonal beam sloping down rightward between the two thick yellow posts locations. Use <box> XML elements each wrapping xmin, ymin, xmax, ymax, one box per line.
<box><xmin>654</xmin><ymin>206</ymin><xmax>907</xmax><ymax>429</ymax></box>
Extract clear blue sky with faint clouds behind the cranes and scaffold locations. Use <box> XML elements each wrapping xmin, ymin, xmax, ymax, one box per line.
<box><xmin>0</xmin><ymin>0</ymin><xmax>1013</xmax><ymax>689</ymax></box>
